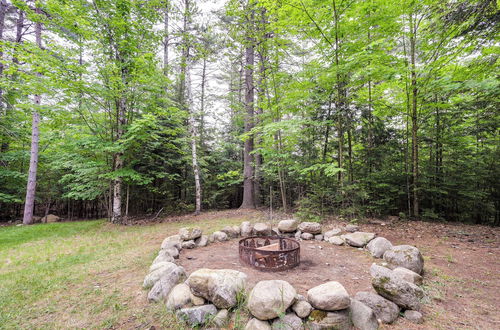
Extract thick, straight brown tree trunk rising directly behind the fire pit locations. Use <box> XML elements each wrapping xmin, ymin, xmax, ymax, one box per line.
<box><xmin>240</xmin><ymin>9</ymin><xmax>255</xmax><ymax>209</ymax></box>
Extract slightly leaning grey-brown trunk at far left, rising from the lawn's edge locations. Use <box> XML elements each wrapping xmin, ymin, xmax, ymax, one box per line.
<box><xmin>23</xmin><ymin>8</ymin><xmax>42</xmax><ymax>225</ymax></box>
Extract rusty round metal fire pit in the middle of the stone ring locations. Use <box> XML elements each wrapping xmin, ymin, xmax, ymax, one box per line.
<box><xmin>239</xmin><ymin>236</ymin><xmax>300</xmax><ymax>272</ymax></box>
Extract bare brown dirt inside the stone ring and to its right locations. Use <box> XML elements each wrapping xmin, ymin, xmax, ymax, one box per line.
<box><xmin>179</xmin><ymin>214</ymin><xmax>500</xmax><ymax>330</ymax></box>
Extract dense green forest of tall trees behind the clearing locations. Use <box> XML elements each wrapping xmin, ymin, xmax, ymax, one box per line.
<box><xmin>0</xmin><ymin>0</ymin><xmax>500</xmax><ymax>226</ymax></box>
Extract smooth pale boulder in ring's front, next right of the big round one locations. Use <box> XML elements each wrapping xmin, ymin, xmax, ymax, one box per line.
<box><xmin>307</xmin><ymin>281</ymin><xmax>351</xmax><ymax>311</ymax></box>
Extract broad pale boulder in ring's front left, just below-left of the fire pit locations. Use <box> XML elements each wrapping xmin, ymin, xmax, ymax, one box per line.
<box><xmin>187</xmin><ymin>268</ymin><xmax>247</xmax><ymax>308</ymax></box>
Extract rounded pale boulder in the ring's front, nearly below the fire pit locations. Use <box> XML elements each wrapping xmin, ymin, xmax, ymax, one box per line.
<box><xmin>247</xmin><ymin>280</ymin><xmax>297</xmax><ymax>320</ymax></box>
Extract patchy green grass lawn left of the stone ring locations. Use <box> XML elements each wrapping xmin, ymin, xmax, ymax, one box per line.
<box><xmin>0</xmin><ymin>212</ymin><xmax>260</xmax><ymax>329</ymax></box>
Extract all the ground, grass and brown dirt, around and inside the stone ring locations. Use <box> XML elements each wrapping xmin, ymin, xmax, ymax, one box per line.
<box><xmin>0</xmin><ymin>210</ymin><xmax>500</xmax><ymax>329</ymax></box>
